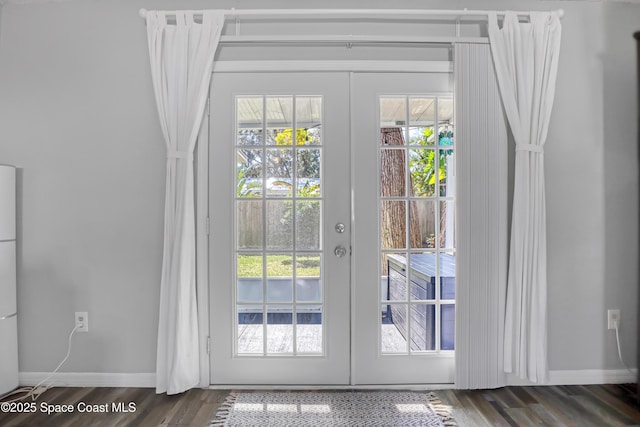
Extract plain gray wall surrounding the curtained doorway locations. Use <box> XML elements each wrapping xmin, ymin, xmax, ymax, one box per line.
<box><xmin>0</xmin><ymin>0</ymin><xmax>640</xmax><ymax>373</ymax></box>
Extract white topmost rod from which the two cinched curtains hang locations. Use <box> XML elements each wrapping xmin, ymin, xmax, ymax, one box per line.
<box><xmin>139</xmin><ymin>9</ymin><xmax>564</xmax><ymax>19</ymax></box>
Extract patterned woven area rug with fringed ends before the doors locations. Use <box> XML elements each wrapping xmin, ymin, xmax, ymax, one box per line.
<box><xmin>211</xmin><ymin>391</ymin><xmax>456</xmax><ymax>427</ymax></box>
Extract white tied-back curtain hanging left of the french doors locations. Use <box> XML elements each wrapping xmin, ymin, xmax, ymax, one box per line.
<box><xmin>146</xmin><ymin>11</ymin><xmax>224</xmax><ymax>394</ymax></box>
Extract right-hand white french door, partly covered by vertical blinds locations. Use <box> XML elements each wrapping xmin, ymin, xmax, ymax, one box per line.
<box><xmin>351</xmin><ymin>73</ymin><xmax>456</xmax><ymax>384</ymax></box>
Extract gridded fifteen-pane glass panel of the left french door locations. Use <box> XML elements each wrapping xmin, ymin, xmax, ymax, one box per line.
<box><xmin>234</xmin><ymin>95</ymin><xmax>325</xmax><ymax>356</ymax></box>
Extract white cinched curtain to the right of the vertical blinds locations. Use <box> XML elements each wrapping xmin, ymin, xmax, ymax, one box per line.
<box><xmin>489</xmin><ymin>12</ymin><xmax>561</xmax><ymax>382</ymax></box>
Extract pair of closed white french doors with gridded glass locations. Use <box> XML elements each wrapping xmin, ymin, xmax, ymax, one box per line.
<box><xmin>209</xmin><ymin>73</ymin><xmax>455</xmax><ymax>385</ymax></box>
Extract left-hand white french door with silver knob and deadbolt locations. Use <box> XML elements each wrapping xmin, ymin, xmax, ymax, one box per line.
<box><xmin>209</xmin><ymin>73</ymin><xmax>350</xmax><ymax>384</ymax></box>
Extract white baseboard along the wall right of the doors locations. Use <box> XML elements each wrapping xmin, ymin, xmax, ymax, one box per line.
<box><xmin>507</xmin><ymin>369</ymin><xmax>638</xmax><ymax>385</ymax></box>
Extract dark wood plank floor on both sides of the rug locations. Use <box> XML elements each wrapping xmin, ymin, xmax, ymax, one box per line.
<box><xmin>0</xmin><ymin>385</ymin><xmax>640</xmax><ymax>427</ymax></box>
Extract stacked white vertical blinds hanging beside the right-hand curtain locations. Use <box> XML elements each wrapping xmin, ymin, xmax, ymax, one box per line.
<box><xmin>454</xmin><ymin>43</ymin><xmax>508</xmax><ymax>389</ymax></box>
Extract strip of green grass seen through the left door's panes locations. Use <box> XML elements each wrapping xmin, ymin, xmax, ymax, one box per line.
<box><xmin>238</xmin><ymin>255</ymin><xmax>320</xmax><ymax>277</ymax></box>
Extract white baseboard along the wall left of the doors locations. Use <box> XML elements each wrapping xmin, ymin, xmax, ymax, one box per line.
<box><xmin>18</xmin><ymin>372</ymin><xmax>156</xmax><ymax>388</ymax></box>
